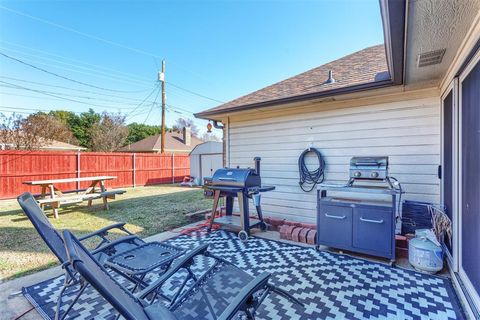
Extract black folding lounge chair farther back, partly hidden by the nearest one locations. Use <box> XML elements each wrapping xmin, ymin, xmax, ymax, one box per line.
<box><xmin>18</xmin><ymin>192</ymin><xmax>186</xmax><ymax>319</ymax></box>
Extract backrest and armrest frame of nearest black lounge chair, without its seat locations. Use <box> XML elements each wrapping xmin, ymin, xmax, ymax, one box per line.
<box><xmin>63</xmin><ymin>230</ymin><xmax>303</xmax><ymax>320</ymax></box>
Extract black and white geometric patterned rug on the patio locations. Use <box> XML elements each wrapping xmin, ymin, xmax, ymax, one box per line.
<box><xmin>23</xmin><ymin>231</ymin><xmax>464</xmax><ymax>320</ymax></box>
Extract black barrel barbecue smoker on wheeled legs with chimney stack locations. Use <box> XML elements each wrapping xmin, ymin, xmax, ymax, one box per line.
<box><xmin>205</xmin><ymin>157</ymin><xmax>275</xmax><ymax>241</ymax></box>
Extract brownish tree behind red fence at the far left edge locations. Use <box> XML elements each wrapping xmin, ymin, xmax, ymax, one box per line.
<box><xmin>0</xmin><ymin>113</ymin><xmax>75</xmax><ymax>150</ymax></box>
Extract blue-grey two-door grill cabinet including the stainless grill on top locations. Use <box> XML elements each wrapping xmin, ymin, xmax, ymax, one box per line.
<box><xmin>317</xmin><ymin>156</ymin><xmax>403</xmax><ymax>265</ymax></box>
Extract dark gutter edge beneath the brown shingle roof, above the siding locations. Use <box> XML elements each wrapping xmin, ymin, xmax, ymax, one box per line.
<box><xmin>195</xmin><ymin>80</ymin><xmax>395</xmax><ymax>120</ymax></box>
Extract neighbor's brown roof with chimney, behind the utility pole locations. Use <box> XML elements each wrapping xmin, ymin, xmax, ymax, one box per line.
<box><xmin>118</xmin><ymin>131</ymin><xmax>203</xmax><ymax>153</ymax></box>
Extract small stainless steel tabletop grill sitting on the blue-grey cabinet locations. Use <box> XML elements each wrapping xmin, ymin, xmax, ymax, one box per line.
<box><xmin>348</xmin><ymin>157</ymin><xmax>393</xmax><ymax>188</ymax></box>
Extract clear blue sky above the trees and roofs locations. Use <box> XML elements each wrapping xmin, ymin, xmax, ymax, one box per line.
<box><xmin>0</xmin><ymin>0</ymin><xmax>383</xmax><ymax>136</ymax></box>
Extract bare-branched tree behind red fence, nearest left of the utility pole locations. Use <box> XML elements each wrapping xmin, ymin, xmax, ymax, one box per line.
<box><xmin>90</xmin><ymin>112</ymin><xmax>128</xmax><ymax>152</ymax></box>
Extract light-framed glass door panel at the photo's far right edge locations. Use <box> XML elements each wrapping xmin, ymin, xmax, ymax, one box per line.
<box><xmin>459</xmin><ymin>48</ymin><xmax>480</xmax><ymax>306</ymax></box>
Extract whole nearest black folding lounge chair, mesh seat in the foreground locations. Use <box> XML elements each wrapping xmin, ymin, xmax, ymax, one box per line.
<box><xmin>63</xmin><ymin>230</ymin><xmax>302</xmax><ymax>320</ymax></box>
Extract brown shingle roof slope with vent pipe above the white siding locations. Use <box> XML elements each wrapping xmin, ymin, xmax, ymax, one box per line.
<box><xmin>197</xmin><ymin>44</ymin><xmax>390</xmax><ymax>117</ymax></box>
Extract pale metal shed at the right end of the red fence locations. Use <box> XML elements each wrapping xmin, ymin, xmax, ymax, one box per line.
<box><xmin>190</xmin><ymin>141</ymin><xmax>223</xmax><ymax>184</ymax></box>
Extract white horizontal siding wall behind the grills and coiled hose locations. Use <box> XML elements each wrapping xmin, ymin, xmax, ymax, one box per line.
<box><xmin>228</xmin><ymin>98</ymin><xmax>440</xmax><ymax>222</ymax></box>
